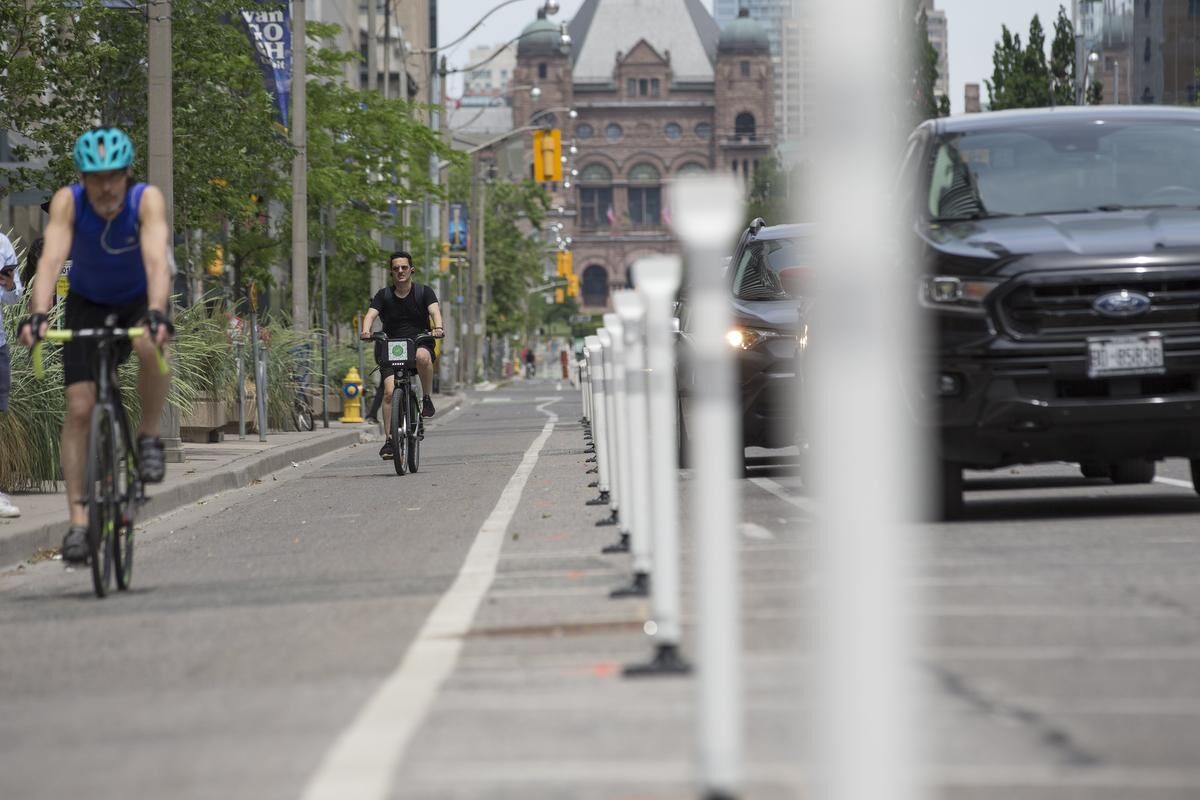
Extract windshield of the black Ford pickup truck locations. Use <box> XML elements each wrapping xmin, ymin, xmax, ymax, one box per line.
<box><xmin>928</xmin><ymin>118</ymin><xmax>1200</xmax><ymax>221</ymax></box>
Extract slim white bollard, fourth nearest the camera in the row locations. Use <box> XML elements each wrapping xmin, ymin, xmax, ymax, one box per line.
<box><xmin>610</xmin><ymin>290</ymin><xmax>654</xmax><ymax>597</ymax></box>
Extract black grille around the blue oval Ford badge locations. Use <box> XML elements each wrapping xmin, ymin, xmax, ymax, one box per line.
<box><xmin>1000</xmin><ymin>277</ymin><xmax>1200</xmax><ymax>337</ymax></box>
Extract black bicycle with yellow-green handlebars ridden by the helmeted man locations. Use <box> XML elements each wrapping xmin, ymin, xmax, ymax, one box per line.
<box><xmin>32</xmin><ymin>315</ymin><xmax>168</xmax><ymax>597</ymax></box>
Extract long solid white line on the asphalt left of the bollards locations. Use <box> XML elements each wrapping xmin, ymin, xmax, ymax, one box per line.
<box><xmin>302</xmin><ymin>401</ymin><xmax>558</xmax><ymax>800</ymax></box>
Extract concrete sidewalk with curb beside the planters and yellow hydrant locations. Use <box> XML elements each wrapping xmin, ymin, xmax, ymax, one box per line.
<box><xmin>0</xmin><ymin>393</ymin><xmax>463</xmax><ymax>567</ymax></box>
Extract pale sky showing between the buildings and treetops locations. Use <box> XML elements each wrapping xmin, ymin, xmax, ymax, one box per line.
<box><xmin>438</xmin><ymin>0</ymin><xmax>1070</xmax><ymax>112</ymax></box>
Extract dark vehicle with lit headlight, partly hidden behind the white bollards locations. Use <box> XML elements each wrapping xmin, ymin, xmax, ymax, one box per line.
<box><xmin>677</xmin><ymin>218</ymin><xmax>811</xmax><ymax>461</ymax></box>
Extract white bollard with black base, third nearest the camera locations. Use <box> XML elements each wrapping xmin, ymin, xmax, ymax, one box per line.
<box><xmin>625</xmin><ymin>255</ymin><xmax>691</xmax><ymax>676</ymax></box>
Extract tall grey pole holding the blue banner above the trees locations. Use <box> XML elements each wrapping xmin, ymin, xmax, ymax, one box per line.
<box><xmin>292</xmin><ymin>0</ymin><xmax>310</xmax><ymax>331</ymax></box>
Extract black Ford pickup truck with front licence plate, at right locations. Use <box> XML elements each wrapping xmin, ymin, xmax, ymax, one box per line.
<box><xmin>904</xmin><ymin>106</ymin><xmax>1200</xmax><ymax>516</ymax></box>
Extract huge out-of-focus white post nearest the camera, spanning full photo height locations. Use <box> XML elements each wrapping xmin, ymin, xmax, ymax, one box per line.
<box><xmin>806</xmin><ymin>0</ymin><xmax>926</xmax><ymax>800</ymax></box>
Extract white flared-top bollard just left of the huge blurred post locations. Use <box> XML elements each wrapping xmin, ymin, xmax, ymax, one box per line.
<box><xmin>670</xmin><ymin>173</ymin><xmax>743</xmax><ymax>798</ymax></box>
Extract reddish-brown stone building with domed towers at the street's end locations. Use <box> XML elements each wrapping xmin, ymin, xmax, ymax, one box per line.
<box><xmin>501</xmin><ymin>0</ymin><xmax>776</xmax><ymax>311</ymax></box>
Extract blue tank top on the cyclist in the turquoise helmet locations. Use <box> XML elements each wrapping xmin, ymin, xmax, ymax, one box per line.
<box><xmin>70</xmin><ymin>184</ymin><xmax>146</xmax><ymax>306</ymax></box>
